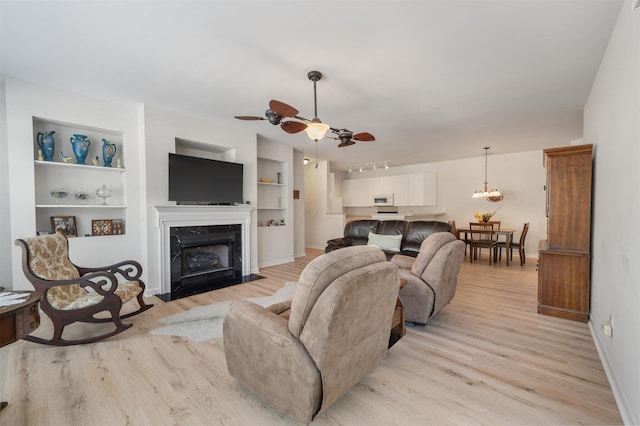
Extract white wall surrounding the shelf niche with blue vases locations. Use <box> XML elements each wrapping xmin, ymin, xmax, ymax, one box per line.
<box><xmin>2</xmin><ymin>79</ymin><xmax>146</xmax><ymax>289</ymax></box>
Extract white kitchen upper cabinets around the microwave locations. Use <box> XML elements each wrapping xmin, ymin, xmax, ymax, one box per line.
<box><xmin>342</xmin><ymin>172</ymin><xmax>437</xmax><ymax>207</ymax></box>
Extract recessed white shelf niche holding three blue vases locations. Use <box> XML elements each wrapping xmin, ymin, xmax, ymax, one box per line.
<box><xmin>32</xmin><ymin>117</ymin><xmax>126</xmax><ymax>236</ymax></box>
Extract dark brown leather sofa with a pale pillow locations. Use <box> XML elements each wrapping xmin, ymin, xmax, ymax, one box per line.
<box><xmin>324</xmin><ymin>220</ymin><xmax>453</xmax><ymax>259</ymax></box>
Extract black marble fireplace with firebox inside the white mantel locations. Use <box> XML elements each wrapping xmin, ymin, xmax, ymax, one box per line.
<box><xmin>169</xmin><ymin>224</ymin><xmax>242</xmax><ymax>299</ymax></box>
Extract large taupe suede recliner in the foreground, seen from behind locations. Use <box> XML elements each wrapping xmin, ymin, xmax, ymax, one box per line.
<box><xmin>223</xmin><ymin>246</ymin><xmax>400</xmax><ymax>423</ymax></box>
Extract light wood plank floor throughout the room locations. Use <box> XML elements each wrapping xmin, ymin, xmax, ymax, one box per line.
<box><xmin>0</xmin><ymin>250</ymin><xmax>622</xmax><ymax>426</ymax></box>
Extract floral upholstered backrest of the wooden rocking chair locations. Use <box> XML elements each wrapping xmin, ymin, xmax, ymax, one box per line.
<box><xmin>24</xmin><ymin>234</ymin><xmax>80</xmax><ymax>281</ymax></box>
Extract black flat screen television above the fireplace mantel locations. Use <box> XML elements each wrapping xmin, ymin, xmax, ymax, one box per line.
<box><xmin>169</xmin><ymin>153</ymin><xmax>243</xmax><ymax>205</ymax></box>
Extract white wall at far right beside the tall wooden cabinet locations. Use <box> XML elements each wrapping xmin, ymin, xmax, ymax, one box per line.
<box><xmin>584</xmin><ymin>0</ymin><xmax>640</xmax><ymax>424</ymax></box>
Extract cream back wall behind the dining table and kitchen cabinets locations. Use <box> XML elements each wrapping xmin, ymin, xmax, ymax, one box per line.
<box><xmin>333</xmin><ymin>150</ymin><xmax>548</xmax><ymax>258</ymax></box>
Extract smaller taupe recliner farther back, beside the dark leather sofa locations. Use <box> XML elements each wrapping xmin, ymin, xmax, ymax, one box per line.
<box><xmin>391</xmin><ymin>232</ymin><xmax>466</xmax><ymax>325</ymax></box>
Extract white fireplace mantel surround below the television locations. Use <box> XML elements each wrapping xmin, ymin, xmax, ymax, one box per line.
<box><xmin>153</xmin><ymin>205</ymin><xmax>254</xmax><ymax>294</ymax></box>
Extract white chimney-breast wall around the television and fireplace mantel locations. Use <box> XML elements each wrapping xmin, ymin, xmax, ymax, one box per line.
<box><xmin>142</xmin><ymin>106</ymin><xmax>258</xmax><ymax>293</ymax></box>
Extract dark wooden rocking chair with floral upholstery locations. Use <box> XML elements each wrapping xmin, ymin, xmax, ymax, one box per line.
<box><xmin>16</xmin><ymin>234</ymin><xmax>153</xmax><ymax>346</ymax></box>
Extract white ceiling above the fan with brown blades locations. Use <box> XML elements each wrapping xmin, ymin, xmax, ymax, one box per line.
<box><xmin>0</xmin><ymin>0</ymin><xmax>622</xmax><ymax>169</ymax></box>
